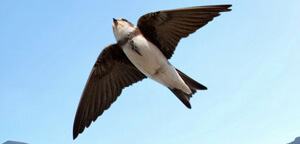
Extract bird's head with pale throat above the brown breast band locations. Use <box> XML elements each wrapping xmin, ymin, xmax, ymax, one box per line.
<box><xmin>113</xmin><ymin>18</ymin><xmax>135</xmax><ymax>41</ymax></box>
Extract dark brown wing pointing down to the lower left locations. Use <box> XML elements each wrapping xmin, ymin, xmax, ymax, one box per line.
<box><xmin>73</xmin><ymin>44</ymin><xmax>146</xmax><ymax>139</ymax></box>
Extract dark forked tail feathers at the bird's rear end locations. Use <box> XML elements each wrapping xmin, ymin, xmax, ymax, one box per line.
<box><xmin>169</xmin><ymin>69</ymin><xmax>207</xmax><ymax>108</ymax></box>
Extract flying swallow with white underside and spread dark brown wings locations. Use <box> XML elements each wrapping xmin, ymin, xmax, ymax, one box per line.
<box><xmin>73</xmin><ymin>5</ymin><xmax>231</xmax><ymax>139</ymax></box>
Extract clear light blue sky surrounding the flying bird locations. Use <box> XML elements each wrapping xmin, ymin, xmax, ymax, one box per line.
<box><xmin>0</xmin><ymin>0</ymin><xmax>300</xmax><ymax>144</ymax></box>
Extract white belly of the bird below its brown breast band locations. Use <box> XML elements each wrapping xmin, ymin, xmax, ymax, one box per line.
<box><xmin>123</xmin><ymin>36</ymin><xmax>191</xmax><ymax>93</ymax></box>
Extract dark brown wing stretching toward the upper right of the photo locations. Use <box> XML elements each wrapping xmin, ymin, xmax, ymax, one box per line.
<box><xmin>137</xmin><ymin>5</ymin><xmax>231</xmax><ymax>59</ymax></box>
